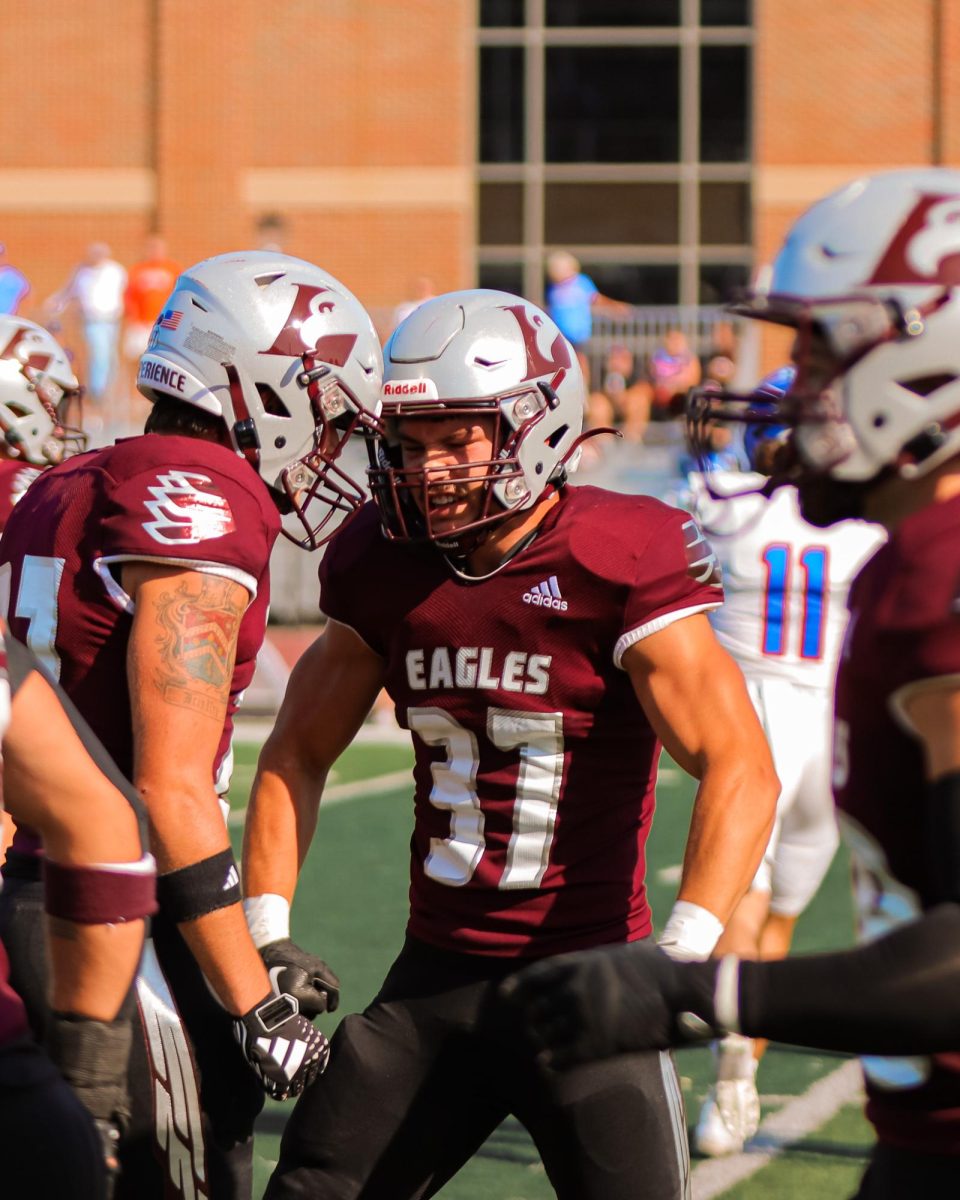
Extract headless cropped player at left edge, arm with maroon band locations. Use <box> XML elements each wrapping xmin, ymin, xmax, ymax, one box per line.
<box><xmin>0</xmin><ymin>622</ymin><xmax>156</xmax><ymax>1200</ymax></box>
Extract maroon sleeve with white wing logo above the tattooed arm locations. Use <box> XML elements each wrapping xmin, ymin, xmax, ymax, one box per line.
<box><xmin>101</xmin><ymin>462</ymin><xmax>277</xmax><ymax>595</ymax></box>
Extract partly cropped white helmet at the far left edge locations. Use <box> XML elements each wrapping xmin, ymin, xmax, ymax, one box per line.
<box><xmin>0</xmin><ymin>316</ymin><xmax>86</xmax><ymax>467</ymax></box>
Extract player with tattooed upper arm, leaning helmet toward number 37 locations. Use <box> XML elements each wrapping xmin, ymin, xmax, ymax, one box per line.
<box><xmin>0</xmin><ymin>252</ymin><xmax>383</xmax><ymax>1200</ymax></box>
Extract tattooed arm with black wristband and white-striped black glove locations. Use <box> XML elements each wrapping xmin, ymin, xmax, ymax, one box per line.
<box><xmin>121</xmin><ymin>563</ymin><xmax>330</xmax><ymax>1099</ymax></box>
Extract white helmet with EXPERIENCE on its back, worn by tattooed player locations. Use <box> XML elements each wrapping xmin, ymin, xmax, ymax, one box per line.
<box><xmin>137</xmin><ymin>251</ymin><xmax>383</xmax><ymax>550</ymax></box>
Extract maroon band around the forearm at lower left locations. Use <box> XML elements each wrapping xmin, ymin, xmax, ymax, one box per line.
<box><xmin>42</xmin><ymin>854</ymin><xmax>157</xmax><ymax>925</ymax></box>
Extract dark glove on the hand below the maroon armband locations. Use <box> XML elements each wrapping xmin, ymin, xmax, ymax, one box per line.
<box><xmin>47</xmin><ymin>1013</ymin><xmax>133</xmax><ymax>1195</ymax></box>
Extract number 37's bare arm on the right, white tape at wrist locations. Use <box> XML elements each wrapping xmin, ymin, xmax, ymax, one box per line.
<box><xmin>623</xmin><ymin>613</ymin><xmax>780</xmax><ymax>958</ymax></box>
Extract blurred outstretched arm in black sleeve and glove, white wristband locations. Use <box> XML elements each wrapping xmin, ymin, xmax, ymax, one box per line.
<box><xmin>502</xmin><ymin>904</ymin><xmax>960</xmax><ymax>1067</ymax></box>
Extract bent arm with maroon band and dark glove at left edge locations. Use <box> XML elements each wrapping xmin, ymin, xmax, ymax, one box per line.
<box><xmin>2</xmin><ymin>657</ymin><xmax>156</xmax><ymax>1152</ymax></box>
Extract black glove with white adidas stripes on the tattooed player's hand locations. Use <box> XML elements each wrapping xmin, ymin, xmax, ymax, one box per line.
<box><xmin>233</xmin><ymin>992</ymin><xmax>330</xmax><ymax>1100</ymax></box>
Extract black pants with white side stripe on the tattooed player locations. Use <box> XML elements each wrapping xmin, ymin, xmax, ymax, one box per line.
<box><xmin>0</xmin><ymin>854</ymin><xmax>263</xmax><ymax>1200</ymax></box>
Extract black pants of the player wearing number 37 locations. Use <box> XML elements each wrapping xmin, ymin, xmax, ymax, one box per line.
<box><xmin>266</xmin><ymin>938</ymin><xmax>689</xmax><ymax>1200</ymax></box>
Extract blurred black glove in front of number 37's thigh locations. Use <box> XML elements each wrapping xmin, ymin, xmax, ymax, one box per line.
<box><xmin>499</xmin><ymin>942</ymin><xmax>719</xmax><ymax>1068</ymax></box>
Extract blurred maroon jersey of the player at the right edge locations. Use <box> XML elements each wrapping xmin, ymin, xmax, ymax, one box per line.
<box><xmin>834</xmin><ymin>499</ymin><xmax>960</xmax><ymax>1154</ymax></box>
